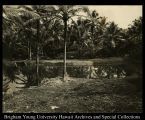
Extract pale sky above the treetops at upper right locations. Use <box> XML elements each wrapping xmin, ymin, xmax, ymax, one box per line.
<box><xmin>88</xmin><ymin>5</ymin><xmax>142</xmax><ymax>28</ymax></box>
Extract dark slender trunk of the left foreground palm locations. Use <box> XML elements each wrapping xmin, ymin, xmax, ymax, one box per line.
<box><xmin>36</xmin><ymin>20</ymin><xmax>40</xmax><ymax>85</ymax></box>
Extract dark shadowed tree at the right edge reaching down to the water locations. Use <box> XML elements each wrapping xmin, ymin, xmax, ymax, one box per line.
<box><xmin>125</xmin><ymin>17</ymin><xmax>143</xmax><ymax>77</ymax></box>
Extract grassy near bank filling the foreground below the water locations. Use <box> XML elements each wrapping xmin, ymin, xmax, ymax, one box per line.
<box><xmin>3</xmin><ymin>77</ymin><xmax>142</xmax><ymax>113</ymax></box>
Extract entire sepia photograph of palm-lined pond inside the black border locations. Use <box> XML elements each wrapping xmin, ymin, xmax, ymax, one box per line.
<box><xmin>2</xmin><ymin>5</ymin><xmax>143</xmax><ymax>113</ymax></box>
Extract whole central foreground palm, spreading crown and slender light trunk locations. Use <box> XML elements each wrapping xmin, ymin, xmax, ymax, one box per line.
<box><xmin>48</xmin><ymin>5</ymin><xmax>86</xmax><ymax>81</ymax></box>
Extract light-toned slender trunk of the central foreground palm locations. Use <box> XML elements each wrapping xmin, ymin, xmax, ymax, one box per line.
<box><xmin>63</xmin><ymin>20</ymin><xmax>67</xmax><ymax>81</ymax></box>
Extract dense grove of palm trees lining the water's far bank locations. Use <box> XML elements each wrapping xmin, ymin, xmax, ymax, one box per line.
<box><xmin>2</xmin><ymin>5</ymin><xmax>142</xmax><ymax>82</ymax></box>
